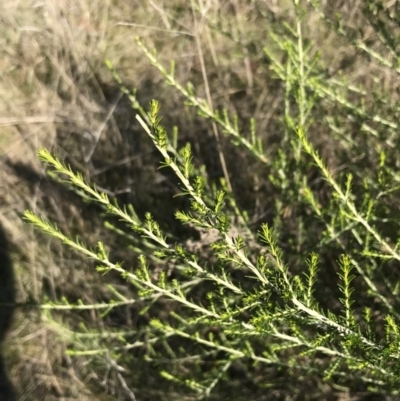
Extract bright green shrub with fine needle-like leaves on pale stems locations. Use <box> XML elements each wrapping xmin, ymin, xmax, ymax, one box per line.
<box><xmin>25</xmin><ymin>0</ymin><xmax>400</xmax><ymax>399</ymax></box>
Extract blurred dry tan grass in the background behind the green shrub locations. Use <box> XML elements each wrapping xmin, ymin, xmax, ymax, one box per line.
<box><xmin>0</xmin><ymin>0</ymin><xmax>400</xmax><ymax>401</ymax></box>
